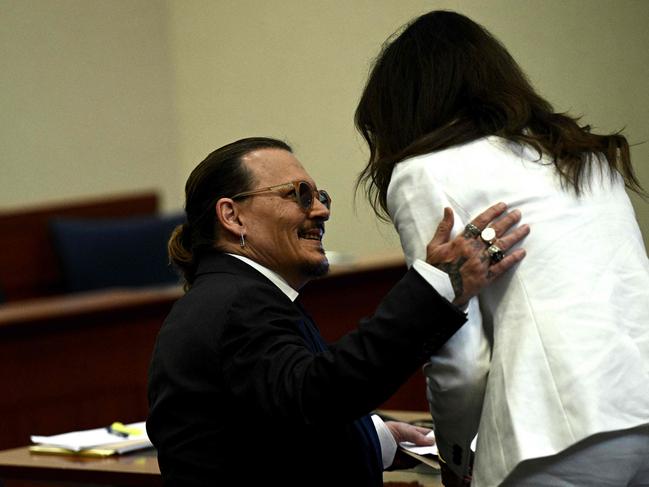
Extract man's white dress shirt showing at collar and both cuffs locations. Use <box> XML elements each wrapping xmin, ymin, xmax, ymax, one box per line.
<box><xmin>228</xmin><ymin>254</ymin><xmax>455</xmax><ymax>468</ymax></box>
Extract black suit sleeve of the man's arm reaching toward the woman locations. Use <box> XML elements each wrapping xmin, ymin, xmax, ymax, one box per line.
<box><xmin>219</xmin><ymin>270</ymin><xmax>466</xmax><ymax>424</ymax></box>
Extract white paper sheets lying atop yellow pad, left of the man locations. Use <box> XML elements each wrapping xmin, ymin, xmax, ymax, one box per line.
<box><xmin>31</xmin><ymin>421</ymin><xmax>149</xmax><ymax>451</ymax></box>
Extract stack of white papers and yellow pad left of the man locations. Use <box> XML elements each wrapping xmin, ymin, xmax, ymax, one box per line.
<box><xmin>30</xmin><ymin>421</ymin><xmax>153</xmax><ymax>456</ymax></box>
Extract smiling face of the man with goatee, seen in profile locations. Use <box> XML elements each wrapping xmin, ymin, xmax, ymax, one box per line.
<box><xmin>237</xmin><ymin>149</ymin><xmax>329</xmax><ymax>289</ymax></box>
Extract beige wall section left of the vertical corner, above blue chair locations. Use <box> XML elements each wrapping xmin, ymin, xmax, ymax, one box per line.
<box><xmin>0</xmin><ymin>0</ymin><xmax>184</xmax><ymax>212</ymax></box>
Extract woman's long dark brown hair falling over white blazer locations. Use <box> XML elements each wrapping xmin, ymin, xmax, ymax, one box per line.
<box><xmin>355</xmin><ymin>11</ymin><xmax>644</xmax><ymax>218</ymax></box>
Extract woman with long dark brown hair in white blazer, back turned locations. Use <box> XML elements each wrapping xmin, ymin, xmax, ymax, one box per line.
<box><xmin>356</xmin><ymin>11</ymin><xmax>649</xmax><ymax>487</ymax></box>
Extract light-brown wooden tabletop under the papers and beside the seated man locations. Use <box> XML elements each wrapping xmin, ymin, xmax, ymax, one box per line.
<box><xmin>0</xmin><ymin>410</ymin><xmax>442</xmax><ymax>487</ymax></box>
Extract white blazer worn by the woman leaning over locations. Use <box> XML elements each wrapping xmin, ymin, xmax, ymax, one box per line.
<box><xmin>387</xmin><ymin>137</ymin><xmax>649</xmax><ymax>487</ymax></box>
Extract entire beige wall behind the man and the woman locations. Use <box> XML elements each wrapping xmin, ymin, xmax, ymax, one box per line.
<box><xmin>0</xmin><ymin>0</ymin><xmax>649</xmax><ymax>260</ymax></box>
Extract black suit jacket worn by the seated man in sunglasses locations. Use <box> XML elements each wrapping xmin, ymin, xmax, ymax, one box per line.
<box><xmin>147</xmin><ymin>253</ymin><xmax>465</xmax><ymax>487</ymax></box>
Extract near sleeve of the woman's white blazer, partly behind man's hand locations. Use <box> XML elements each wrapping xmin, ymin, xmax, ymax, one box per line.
<box><xmin>388</xmin><ymin>161</ymin><xmax>491</xmax><ymax>476</ymax></box>
